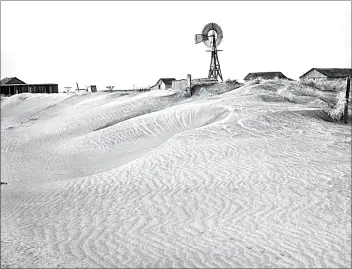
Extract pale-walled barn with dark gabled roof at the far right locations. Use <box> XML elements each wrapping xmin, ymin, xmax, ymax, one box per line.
<box><xmin>299</xmin><ymin>68</ymin><xmax>352</xmax><ymax>81</ymax></box>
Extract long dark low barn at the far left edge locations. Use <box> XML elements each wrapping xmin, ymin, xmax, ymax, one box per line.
<box><xmin>0</xmin><ymin>77</ymin><xmax>59</xmax><ymax>95</ymax></box>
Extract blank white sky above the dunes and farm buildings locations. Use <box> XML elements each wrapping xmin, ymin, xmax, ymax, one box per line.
<box><xmin>1</xmin><ymin>1</ymin><xmax>351</xmax><ymax>91</ymax></box>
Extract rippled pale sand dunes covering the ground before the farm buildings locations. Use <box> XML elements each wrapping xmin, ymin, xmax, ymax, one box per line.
<box><xmin>1</xmin><ymin>79</ymin><xmax>351</xmax><ymax>268</ymax></box>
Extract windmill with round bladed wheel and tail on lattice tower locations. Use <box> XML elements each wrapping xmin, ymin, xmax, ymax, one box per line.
<box><xmin>194</xmin><ymin>22</ymin><xmax>223</xmax><ymax>81</ymax></box>
